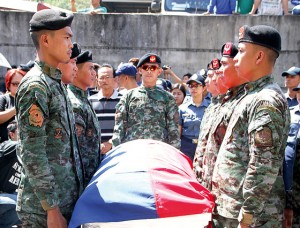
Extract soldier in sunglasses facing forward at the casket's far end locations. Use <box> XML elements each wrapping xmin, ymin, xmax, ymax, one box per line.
<box><xmin>112</xmin><ymin>53</ymin><xmax>180</xmax><ymax>149</ymax></box>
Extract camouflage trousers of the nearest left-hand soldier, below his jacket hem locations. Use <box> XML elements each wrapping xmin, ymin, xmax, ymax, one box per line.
<box><xmin>17</xmin><ymin>212</ymin><xmax>72</xmax><ymax>228</ymax></box>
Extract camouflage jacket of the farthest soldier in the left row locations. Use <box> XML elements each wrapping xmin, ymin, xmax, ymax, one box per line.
<box><xmin>68</xmin><ymin>85</ymin><xmax>101</xmax><ymax>185</ymax></box>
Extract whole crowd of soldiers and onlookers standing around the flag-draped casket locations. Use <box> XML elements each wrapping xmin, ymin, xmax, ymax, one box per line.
<box><xmin>0</xmin><ymin>6</ymin><xmax>300</xmax><ymax>227</ymax></box>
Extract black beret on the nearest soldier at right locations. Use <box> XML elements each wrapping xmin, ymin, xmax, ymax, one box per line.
<box><xmin>239</xmin><ymin>25</ymin><xmax>281</xmax><ymax>55</ymax></box>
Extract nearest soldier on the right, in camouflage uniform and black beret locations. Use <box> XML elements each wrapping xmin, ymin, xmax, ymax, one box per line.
<box><xmin>212</xmin><ymin>25</ymin><xmax>289</xmax><ymax>227</ymax></box>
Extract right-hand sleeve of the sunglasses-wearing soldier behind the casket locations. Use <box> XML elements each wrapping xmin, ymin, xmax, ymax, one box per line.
<box><xmin>166</xmin><ymin>97</ymin><xmax>180</xmax><ymax>149</ymax></box>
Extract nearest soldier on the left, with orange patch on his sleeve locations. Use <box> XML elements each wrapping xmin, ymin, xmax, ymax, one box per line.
<box><xmin>16</xmin><ymin>9</ymin><xmax>83</xmax><ymax>227</ymax></box>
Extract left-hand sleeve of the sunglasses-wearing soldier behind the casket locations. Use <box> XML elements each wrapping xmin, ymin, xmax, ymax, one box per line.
<box><xmin>112</xmin><ymin>95</ymin><xmax>128</xmax><ymax>147</ymax></box>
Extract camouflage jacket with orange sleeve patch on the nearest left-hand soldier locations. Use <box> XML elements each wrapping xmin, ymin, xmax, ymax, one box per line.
<box><xmin>16</xmin><ymin>62</ymin><xmax>83</xmax><ymax>214</ymax></box>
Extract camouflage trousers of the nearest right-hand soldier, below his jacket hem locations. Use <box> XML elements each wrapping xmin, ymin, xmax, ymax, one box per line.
<box><xmin>213</xmin><ymin>215</ymin><xmax>282</xmax><ymax>228</ymax></box>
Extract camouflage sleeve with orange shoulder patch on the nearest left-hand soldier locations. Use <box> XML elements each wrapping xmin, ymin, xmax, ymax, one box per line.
<box><xmin>16</xmin><ymin>83</ymin><xmax>59</xmax><ymax>210</ymax></box>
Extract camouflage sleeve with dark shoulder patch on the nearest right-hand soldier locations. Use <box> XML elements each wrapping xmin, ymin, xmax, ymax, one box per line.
<box><xmin>240</xmin><ymin>101</ymin><xmax>289</xmax><ymax>214</ymax></box>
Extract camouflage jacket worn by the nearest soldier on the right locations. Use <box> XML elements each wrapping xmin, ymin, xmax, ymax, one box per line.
<box><xmin>212</xmin><ymin>76</ymin><xmax>290</xmax><ymax>226</ymax></box>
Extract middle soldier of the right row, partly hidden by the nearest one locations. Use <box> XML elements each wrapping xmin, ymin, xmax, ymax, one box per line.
<box><xmin>194</xmin><ymin>42</ymin><xmax>245</xmax><ymax>191</ymax></box>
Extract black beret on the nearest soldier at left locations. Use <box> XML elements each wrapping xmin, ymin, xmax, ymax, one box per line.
<box><xmin>29</xmin><ymin>9</ymin><xmax>74</xmax><ymax>32</ymax></box>
